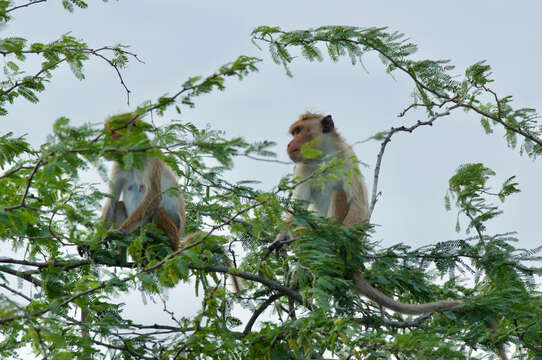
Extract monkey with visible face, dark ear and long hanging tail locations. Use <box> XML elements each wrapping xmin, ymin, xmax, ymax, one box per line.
<box><xmin>275</xmin><ymin>112</ymin><xmax>463</xmax><ymax>314</ymax></box>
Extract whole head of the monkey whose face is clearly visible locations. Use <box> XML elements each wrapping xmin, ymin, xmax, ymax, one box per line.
<box><xmin>287</xmin><ymin>112</ymin><xmax>337</xmax><ymax>163</ymax></box>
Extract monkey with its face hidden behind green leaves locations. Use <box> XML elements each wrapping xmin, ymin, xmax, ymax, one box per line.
<box><xmin>102</xmin><ymin>113</ymin><xmax>185</xmax><ymax>262</ymax></box>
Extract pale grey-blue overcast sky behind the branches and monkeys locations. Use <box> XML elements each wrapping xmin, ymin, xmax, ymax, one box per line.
<box><xmin>2</xmin><ymin>0</ymin><xmax>542</xmax><ymax>350</ymax></box>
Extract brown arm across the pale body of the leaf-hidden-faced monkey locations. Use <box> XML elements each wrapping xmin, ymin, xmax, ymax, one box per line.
<box><xmin>117</xmin><ymin>158</ymin><xmax>163</xmax><ymax>234</ymax></box>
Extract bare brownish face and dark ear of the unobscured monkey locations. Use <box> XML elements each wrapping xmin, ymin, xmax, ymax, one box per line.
<box><xmin>287</xmin><ymin>115</ymin><xmax>334</xmax><ymax>163</ymax></box>
